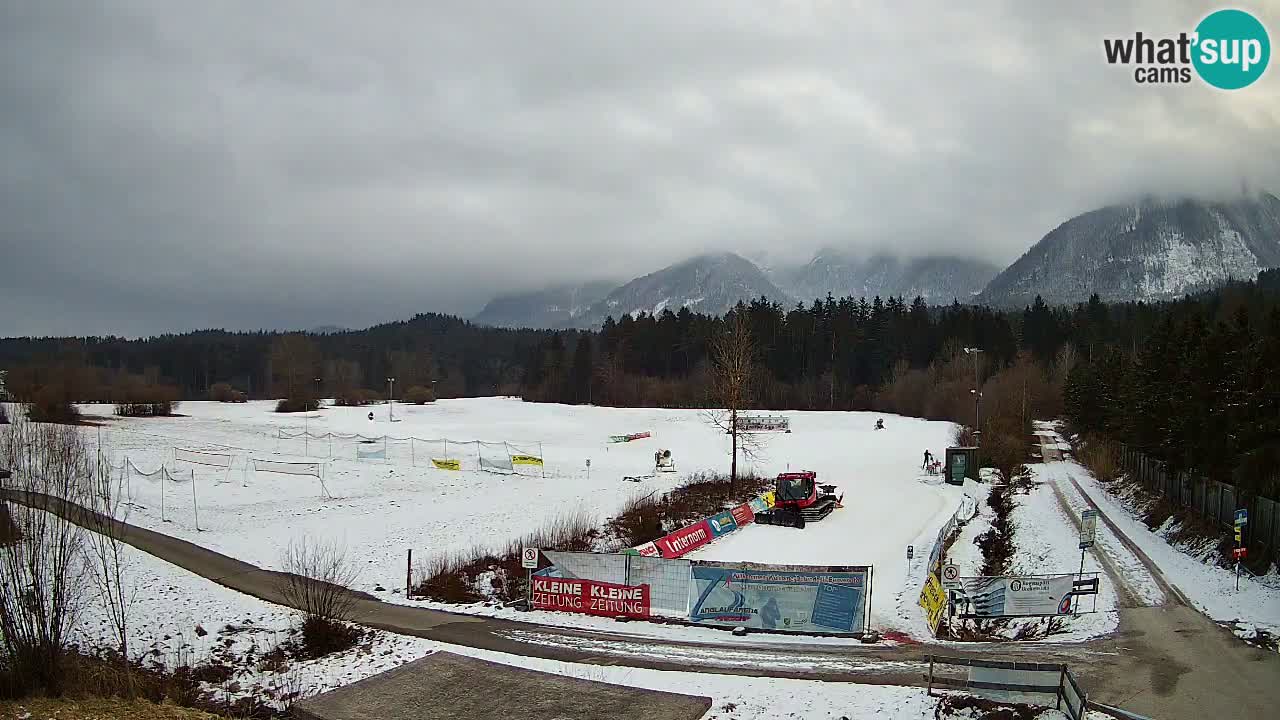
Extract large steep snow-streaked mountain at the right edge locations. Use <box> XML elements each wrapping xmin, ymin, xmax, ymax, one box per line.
<box><xmin>978</xmin><ymin>193</ymin><xmax>1280</xmax><ymax>306</ymax></box>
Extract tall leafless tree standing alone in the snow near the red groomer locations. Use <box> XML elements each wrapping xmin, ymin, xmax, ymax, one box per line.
<box><xmin>707</xmin><ymin>307</ymin><xmax>763</xmax><ymax>495</ymax></box>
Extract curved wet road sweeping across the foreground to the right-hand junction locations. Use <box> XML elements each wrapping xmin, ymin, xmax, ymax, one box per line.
<box><xmin>0</xmin><ymin>481</ymin><xmax>1280</xmax><ymax>719</ymax></box>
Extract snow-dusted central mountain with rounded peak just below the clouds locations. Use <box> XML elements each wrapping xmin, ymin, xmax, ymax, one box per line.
<box><xmin>575</xmin><ymin>252</ymin><xmax>792</xmax><ymax>327</ymax></box>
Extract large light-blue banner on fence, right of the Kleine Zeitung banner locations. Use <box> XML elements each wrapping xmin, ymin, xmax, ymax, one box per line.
<box><xmin>689</xmin><ymin>562</ymin><xmax>870</xmax><ymax>633</ymax></box>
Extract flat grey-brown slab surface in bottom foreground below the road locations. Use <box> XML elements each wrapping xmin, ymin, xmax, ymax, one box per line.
<box><xmin>293</xmin><ymin>652</ymin><xmax>712</xmax><ymax>720</ymax></box>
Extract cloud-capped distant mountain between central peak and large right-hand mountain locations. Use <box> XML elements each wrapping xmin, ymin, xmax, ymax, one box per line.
<box><xmin>778</xmin><ymin>249</ymin><xmax>1000</xmax><ymax>304</ymax></box>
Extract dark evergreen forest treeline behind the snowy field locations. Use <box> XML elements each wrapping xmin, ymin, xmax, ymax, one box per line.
<box><xmin>0</xmin><ymin>270</ymin><xmax>1280</xmax><ymax>487</ymax></box>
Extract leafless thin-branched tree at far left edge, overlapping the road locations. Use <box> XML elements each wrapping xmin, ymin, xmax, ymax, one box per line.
<box><xmin>0</xmin><ymin>418</ymin><xmax>92</xmax><ymax>694</ymax></box>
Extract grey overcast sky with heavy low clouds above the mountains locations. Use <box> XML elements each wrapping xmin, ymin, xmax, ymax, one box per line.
<box><xmin>0</xmin><ymin>0</ymin><xmax>1280</xmax><ymax>336</ymax></box>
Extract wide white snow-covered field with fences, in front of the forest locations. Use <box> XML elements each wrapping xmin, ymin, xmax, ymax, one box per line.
<box><xmin>86</xmin><ymin>397</ymin><xmax>961</xmax><ymax>632</ymax></box>
